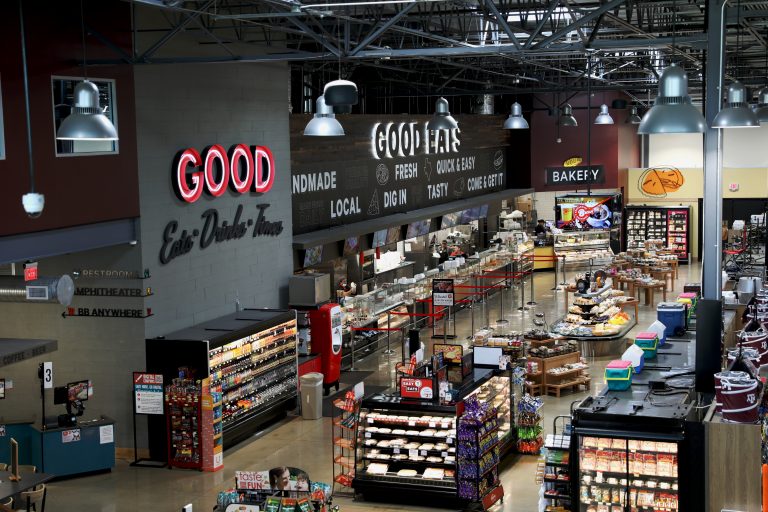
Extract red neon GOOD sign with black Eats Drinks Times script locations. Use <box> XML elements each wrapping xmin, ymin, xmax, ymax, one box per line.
<box><xmin>159</xmin><ymin>144</ymin><xmax>283</xmax><ymax>265</ymax></box>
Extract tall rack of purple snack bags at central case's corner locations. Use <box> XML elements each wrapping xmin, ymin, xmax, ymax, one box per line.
<box><xmin>457</xmin><ymin>399</ymin><xmax>503</xmax><ymax>508</ymax></box>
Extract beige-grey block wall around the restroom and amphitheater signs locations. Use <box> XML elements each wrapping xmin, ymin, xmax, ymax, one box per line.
<box><xmin>0</xmin><ymin>245</ymin><xmax>144</xmax><ymax>448</ymax></box>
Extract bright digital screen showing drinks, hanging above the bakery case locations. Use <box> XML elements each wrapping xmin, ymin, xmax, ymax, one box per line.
<box><xmin>555</xmin><ymin>196</ymin><xmax>621</xmax><ymax>229</ymax></box>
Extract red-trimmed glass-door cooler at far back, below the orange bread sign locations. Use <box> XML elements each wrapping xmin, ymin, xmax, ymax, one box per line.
<box><xmin>624</xmin><ymin>205</ymin><xmax>691</xmax><ymax>262</ymax></box>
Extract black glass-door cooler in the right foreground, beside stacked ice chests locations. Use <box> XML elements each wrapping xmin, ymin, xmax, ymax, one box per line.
<box><xmin>570</xmin><ymin>390</ymin><xmax>704</xmax><ymax>512</ymax></box>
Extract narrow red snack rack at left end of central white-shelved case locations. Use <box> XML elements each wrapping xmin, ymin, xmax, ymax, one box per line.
<box><xmin>332</xmin><ymin>391</ymin><xmax>360</xmax><ymax>495</ymax></box>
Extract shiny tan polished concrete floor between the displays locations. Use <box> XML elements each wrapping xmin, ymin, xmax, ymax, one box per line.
<box><xmin>46</xmin><ymin>265</ymin><xmax>700</xmax><ymax>512</ymax></box>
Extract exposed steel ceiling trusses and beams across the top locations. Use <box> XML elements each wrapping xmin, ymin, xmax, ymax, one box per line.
<box><xmin>111</xmin><ymin>0</ymin><xmax>768</xmax><ymax>105</ymax></box>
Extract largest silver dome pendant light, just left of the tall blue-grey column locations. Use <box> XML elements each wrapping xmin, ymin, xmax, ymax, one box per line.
<box><xmin>637</xmin><ymin>64</ymin><xmax>707</xmax><ymax>135</ymax></box>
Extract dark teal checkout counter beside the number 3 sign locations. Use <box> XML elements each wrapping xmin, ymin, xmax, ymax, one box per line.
<box><xmin>33</xmin><ymin>416</ymin><xmax>115</xmax><ymax>477</ymax></box>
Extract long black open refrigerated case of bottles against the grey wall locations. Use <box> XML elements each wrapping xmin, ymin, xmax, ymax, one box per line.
<box><xmin>146</xmin><ymin>309</ymin><xmax>298</xmax><ymax>460</ymax></box>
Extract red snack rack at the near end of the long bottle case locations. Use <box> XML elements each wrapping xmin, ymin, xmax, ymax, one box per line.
<box><xmin>165</xmin><ymin>378</ymin><xmax>203</xmax><ymax>469</ymax></box>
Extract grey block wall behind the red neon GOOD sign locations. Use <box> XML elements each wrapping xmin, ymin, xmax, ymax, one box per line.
<box><xmin>135</xmin><ymin>64</ymin><xmax>292</xmax><ymax>337</ymax></box>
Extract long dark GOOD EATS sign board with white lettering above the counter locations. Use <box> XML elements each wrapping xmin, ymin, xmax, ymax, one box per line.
<box><xmin>291</xmin><ymin>115</ymin><xmax>510</xmax><ymax>234</ymax></box>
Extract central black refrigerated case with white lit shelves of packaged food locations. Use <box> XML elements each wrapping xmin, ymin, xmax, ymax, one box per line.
<box><xmin>352</xmin><ymin>369</ymin><xmax>514</xmax><ymax>503</ymax></box>
